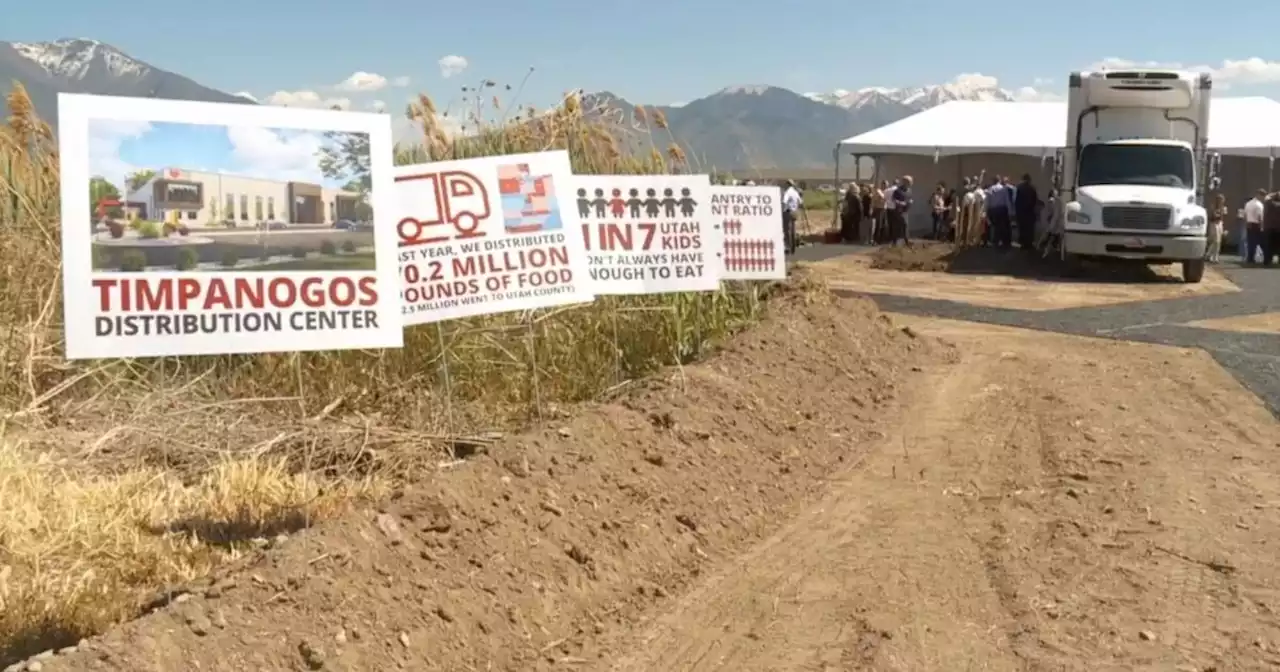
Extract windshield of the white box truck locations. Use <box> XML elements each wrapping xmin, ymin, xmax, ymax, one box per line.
<box><xmin>1079</xmin><ymin>145</ymin><xmax>1196</xmax><ymax>189</ymax></box>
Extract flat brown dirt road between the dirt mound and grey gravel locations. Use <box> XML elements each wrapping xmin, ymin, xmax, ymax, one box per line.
<box><xmin>594</xmin><ymin>320</ymin><xmax>1280</xmax><ymax>672</ymax></box>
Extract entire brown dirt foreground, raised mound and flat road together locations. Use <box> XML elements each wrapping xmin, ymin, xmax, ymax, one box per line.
<box><xmin>15</xmin><ymin>273</ymin><xmax>1280</xmax><ymax>672</ymax></box>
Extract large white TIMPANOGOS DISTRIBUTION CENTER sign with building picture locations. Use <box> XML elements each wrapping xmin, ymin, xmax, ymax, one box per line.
<box><xmin>58</xmin><ymin>93</ymin><xmax>404</xmax><ymax>360</ymax></box>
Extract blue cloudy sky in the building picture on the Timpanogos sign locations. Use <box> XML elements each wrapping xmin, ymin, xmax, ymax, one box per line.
<box><xmin>88</xmin><ymin>119</ymin><xmax>346</xmax><ymax>187</ymax></box>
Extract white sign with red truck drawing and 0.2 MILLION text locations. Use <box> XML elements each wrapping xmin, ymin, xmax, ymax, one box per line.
<box><xmin>394</xmin><ymin>151</ymin><xmax>595</xmax><ymax>325</ymax></box>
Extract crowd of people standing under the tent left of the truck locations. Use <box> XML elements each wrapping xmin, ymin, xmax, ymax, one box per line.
<box><xmin>840</xmin><ymin>175</ymin><xmax>1052</xmax><ymax>250</ymax></box>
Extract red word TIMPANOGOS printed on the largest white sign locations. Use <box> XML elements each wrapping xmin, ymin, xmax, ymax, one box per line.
<box><xmin>92</xmin><ymin>275</ymin><xmax>378</xmax><ymax>312</ymax></box>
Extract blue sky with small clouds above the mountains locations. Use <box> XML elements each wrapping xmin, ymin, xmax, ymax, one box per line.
<box><xmin>3</xmin><ymin>0</ymin><xmax>1280</xmax><ymax>122</ymax></box>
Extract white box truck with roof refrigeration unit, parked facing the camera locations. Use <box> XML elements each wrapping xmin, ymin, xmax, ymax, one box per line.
<box><xmin>1055</xmin><ymin>69</ymin><xmax>1220</xmax><ymax>283</ymax></box>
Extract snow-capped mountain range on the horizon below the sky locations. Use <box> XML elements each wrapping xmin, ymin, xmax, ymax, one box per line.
<box><xmin>0</xmin><ymin>38</ymin><xmax>1014</xmax><ymax>170</ymax></box>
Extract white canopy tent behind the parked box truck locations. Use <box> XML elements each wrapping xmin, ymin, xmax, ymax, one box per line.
<box><xmin>836</xmin><ymin>97</ymin><xmax>1280</xmax><ymax>228</ymax></box>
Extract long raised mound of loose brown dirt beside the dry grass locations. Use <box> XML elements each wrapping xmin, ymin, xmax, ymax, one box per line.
<box><xmin>24</xmin><ymin>284</ymin><xmax>954</xmax><ymax>672</ymax></box>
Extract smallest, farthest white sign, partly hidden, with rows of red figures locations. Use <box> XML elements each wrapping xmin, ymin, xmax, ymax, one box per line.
<box><xmin>712</xmin><ymin>186</ymin><xmax>787</xmax><ymax>280</ymax></box>
